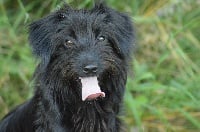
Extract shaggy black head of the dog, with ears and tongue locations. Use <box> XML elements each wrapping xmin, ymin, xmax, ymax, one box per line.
<box><xmin>29</xmin><ymin>4</ymin><xmax>133</xmax><ymax>101</ymax></box>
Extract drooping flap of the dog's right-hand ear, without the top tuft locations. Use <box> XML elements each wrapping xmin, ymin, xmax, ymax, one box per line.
<box><xmin>108</xmin><ymin>10</ymin><xmax>134</xmax><ymax>58</ymax></box>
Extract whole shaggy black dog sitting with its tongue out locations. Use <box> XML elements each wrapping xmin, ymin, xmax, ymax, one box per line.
<box><xmin>0</xmin><ymin>4</ymin><xmax>134</xmax><ymax>132</ymax></box>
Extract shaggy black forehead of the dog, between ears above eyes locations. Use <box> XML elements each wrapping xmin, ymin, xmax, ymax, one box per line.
<box><xmin>57</xmin><ymin>10</ymin><xmax>106</xmax><ymax>39</ymax></box>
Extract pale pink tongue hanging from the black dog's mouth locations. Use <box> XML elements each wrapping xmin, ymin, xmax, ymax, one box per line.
<box><xmin>80</xmin><ymin>77</ymin><xmax>105</xmax><ymax>101</ymax></box>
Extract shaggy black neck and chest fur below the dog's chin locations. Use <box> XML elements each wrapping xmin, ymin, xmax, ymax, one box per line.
<box><xmin>33</xmin><ymin>70</ymin><xmax>126</xmax><ymax>132</ymax></box>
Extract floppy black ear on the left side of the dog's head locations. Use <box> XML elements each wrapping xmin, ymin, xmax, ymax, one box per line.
<box><xmin>29</xmin><ymin>3</ymin><xmax>72</xmax><ymax>67</ymax></box>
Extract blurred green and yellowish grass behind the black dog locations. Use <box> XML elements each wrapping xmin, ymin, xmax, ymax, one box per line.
<box><xmin>0</xmin><ymin>0</ymin><xmax>200</xmax><ymax>132</ymax></box>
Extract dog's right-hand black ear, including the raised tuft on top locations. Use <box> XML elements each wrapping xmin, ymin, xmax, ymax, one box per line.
<box><xmin>92</xmin><ymin>1</ymin><xmax>134</xmax><ymax>58</ymax></box>
